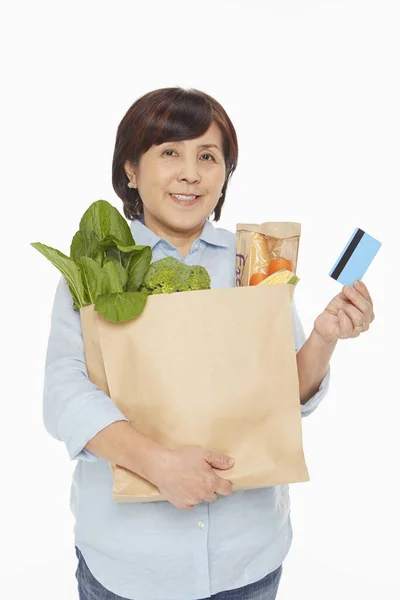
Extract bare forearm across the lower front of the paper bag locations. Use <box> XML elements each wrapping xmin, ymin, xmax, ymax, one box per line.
<box><xmin>85</xmin><ymin>421</ymin><xmax>167</xmax><ymax>483</ymax></box>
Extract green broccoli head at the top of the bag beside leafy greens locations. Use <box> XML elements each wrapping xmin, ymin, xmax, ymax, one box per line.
<box><xmin>140</xmin><ymin>256</ymin><xmax>211</xmax><ymax>295</ymax></box>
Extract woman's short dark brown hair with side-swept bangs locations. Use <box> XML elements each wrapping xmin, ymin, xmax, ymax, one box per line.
<box><xmin>112</xmin><ymin>87</ymin><xmax>238</xmax><ymax>221</ymax></box>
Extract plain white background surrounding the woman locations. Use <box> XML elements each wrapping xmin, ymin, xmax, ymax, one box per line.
<box><xmin>0</xmin><ymin>0</ymin><xmax>400</xmax><ymax>600</ymax></box>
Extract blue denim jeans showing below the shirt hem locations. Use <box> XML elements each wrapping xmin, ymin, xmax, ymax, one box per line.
<box><xmin>75</xmin><ymin>546</ymin><xmax>282</xmax><ymax>600</ymax></box>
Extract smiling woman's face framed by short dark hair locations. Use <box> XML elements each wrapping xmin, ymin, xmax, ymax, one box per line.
<box><xmin>124</xmin><ymin>122</ymin><xmax>226</xmax><ymax>233</ymax></box>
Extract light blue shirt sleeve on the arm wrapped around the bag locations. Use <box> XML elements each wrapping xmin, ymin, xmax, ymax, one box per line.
<box><xmin>43</xmin><ymin>277</ymin><xmax>129</xmax><ymax>461</ymax></box>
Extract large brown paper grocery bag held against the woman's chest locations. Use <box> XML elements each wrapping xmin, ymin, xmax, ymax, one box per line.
<box><xmin>80</xmin><ymin>284</ymin><xmax>309</xmax><ymax>502</ymax></box>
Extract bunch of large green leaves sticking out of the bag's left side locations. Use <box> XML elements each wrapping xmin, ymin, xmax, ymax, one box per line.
<box><xmin>32</xmin><ymin>200</ymin><xmax>148</xmax><ymax>321</ymax></box>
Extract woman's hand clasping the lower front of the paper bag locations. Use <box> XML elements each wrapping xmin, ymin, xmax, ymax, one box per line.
<box><xmin>149</xmin><ymin>446</ymin><xmax>235</xmax><ymax>510</ymax></box>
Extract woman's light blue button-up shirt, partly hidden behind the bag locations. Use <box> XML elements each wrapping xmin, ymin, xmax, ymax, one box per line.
<box><xmin>43</xmin><ymin>216</ymin><xmax>330</xmax><ymax>600</ymax></box>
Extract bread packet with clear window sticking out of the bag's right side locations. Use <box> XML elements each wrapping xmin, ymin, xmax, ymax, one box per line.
<box><xmin>236</xmin><ymin>222</ymin><xmax>301</xmax><ymax>287</ymax></box>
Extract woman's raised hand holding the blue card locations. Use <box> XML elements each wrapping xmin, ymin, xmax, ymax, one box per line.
<box><xmin>314</xmin><ymin>281</ymin><xmax>375</xmax><ymax>343</ymax></box>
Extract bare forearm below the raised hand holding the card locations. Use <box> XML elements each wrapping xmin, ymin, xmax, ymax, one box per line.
<box><xmin>297</xmin><ymin>329</ymin><xmax>337</xmax><ymax>404</ymax></box>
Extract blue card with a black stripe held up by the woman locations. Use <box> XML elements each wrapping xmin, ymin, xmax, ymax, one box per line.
<box><xmin>329</xmin><ymin>228</ymin><xmax>382</xmax><ymax>285</ymax></box>
